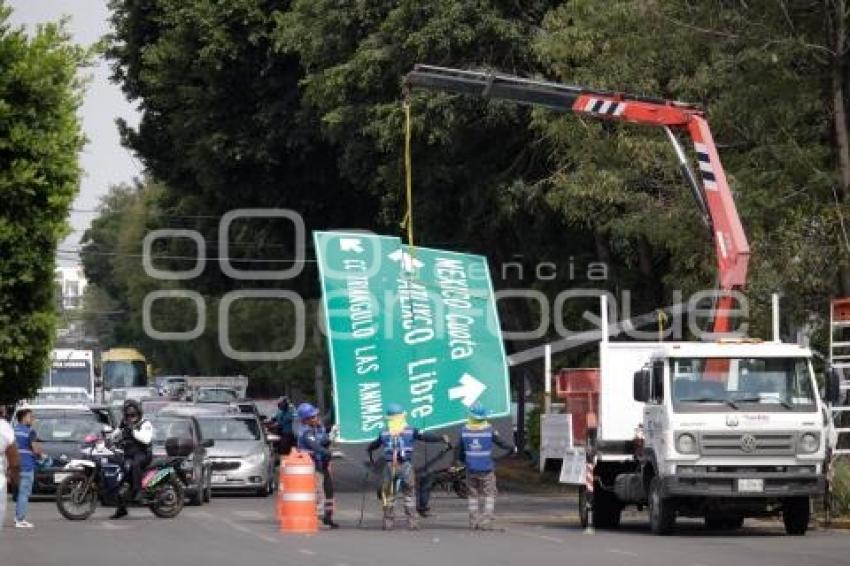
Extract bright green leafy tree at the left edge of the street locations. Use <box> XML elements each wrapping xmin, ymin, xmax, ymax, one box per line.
<box><xmin>0</xmin><ymin>0</ymin><xmax>87</xmax><ymax>403</ymax></box>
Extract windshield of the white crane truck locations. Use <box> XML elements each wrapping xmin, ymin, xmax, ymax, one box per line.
<box><xmin>670</xmin><ymin>358</ymin><xmax>817</xmax><ymax>412</ymax></box>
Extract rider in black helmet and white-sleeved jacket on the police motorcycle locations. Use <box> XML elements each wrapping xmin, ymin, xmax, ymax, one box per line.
<box><xmin>110</xmin><ymin>399</ymin><xmax>153</xmax><ymax>519</ymax></box>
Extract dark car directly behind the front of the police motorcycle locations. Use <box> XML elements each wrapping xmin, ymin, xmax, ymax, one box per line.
<box><xmin>13</xmin><ymin>404</ymin><xmax>112</xmax><ymax>494</ymax></box>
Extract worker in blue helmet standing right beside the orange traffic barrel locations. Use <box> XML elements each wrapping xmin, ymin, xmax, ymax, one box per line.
<box><xmin>296</xmin><ymin>403</ymin><xmax>339</xmax><ymax>529</ymax></box>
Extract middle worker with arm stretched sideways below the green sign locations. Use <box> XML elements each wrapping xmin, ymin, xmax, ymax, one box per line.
<box><xmin>366</xmin><ymin>403</ymin><xmax>451</xmax><ymax>531</ymax></box>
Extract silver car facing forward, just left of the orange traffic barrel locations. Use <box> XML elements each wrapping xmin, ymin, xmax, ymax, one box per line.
<box><xmin>195</xmin><ymin>413</ymin><xmax>277</xmax><ymax>497</ymax></box>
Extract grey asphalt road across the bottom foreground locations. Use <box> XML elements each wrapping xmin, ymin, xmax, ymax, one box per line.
<box><xmin>0</xmin><ymin>460</ymin><xmax>850</xmax><ymax>566</ymax></box>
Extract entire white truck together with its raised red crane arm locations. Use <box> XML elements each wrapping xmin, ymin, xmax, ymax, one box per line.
<box><xmin>405</xmin><ymin>65</ymin><xmax>839</xmax><ymax>535</ymax></box>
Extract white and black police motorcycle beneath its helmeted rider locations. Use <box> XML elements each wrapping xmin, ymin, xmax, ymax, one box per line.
<box><xmin>56</xmin><ymin>426</ymin><xmax>194</xmax><ymax>521</ymax></box>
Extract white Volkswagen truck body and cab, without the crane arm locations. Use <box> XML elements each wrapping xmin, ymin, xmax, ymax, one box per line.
<box><xmin>588</xmin><ymin>341</ymin><xmax>831</xmax><ymax>535</ymax></box>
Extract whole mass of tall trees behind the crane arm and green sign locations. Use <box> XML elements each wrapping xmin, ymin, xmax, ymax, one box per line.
<box><xmin>87</xmin><ymin>0</ymin><xmax>850</xmax><ymax>388</ymax></box>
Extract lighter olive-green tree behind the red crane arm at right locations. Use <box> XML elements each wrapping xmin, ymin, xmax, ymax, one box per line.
<box><xmin>536</xmin><ymin>0</ymin><xmax>850</xmax><ymax>342</ymax></box>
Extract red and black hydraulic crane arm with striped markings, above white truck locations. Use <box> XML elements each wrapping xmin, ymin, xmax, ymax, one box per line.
<box><xmin>405</xmin><ymin>65</ymin><xmax>750</xmax><ymax>333</ymax></box>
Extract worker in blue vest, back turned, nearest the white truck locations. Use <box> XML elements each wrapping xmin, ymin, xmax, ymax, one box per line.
<box><xmin>458</xmin><ymin>403</ymin><xmax>515</xmax><ymax>531</ymax></box>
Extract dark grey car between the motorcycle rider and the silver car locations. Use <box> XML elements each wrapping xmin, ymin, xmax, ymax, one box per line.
<box><xmin>149</xmin><ymin>415</ymin><xmax>215</xmax><ymax>505</ymax></box>
